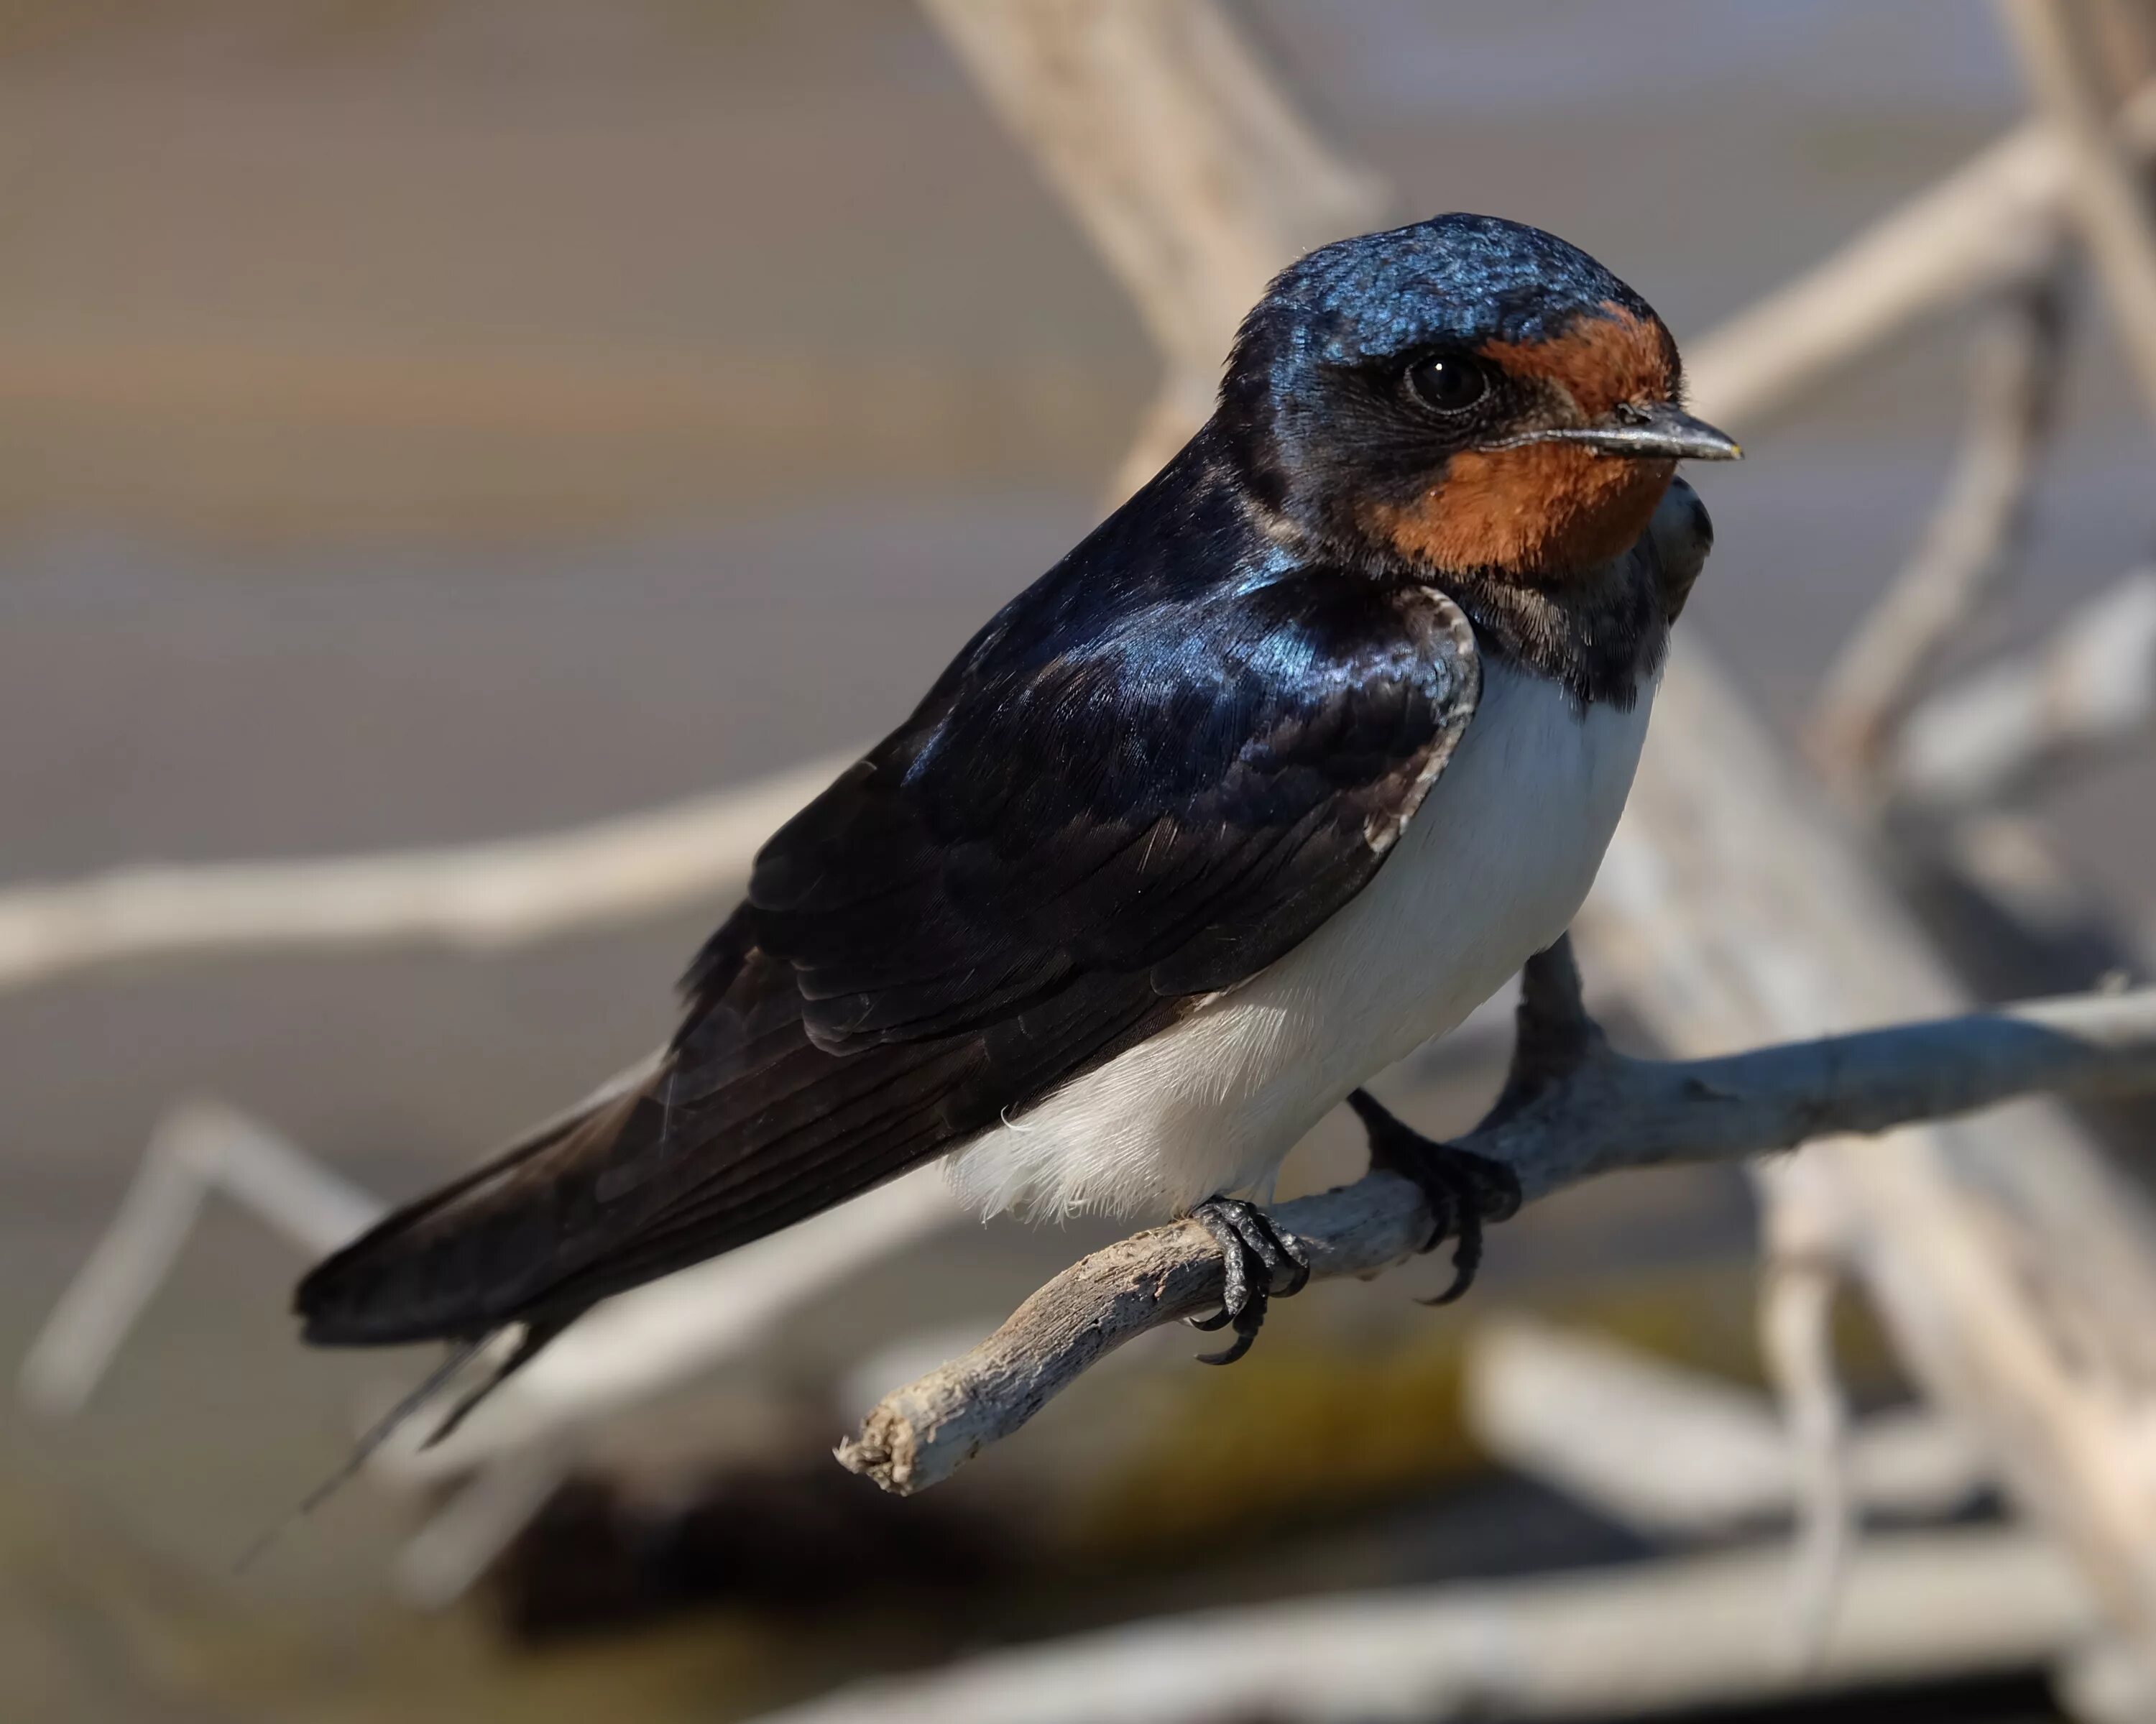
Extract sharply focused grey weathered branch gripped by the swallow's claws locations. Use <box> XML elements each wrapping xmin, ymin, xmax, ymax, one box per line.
<box><xmin>839</xmin><ymin>948</ymin><xmax>2156</xmax><ymax>1493</ymax></box>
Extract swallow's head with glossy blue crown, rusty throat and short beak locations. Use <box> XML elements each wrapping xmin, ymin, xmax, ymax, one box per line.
<box><xmin>1216</xmin><ymin>216</ymin><xmax>1740</xmax><ymax>586</ymax></box>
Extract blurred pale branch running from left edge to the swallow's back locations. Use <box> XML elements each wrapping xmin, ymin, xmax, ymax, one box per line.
<box><xmin>0</xmin><ymin>755</ymin><xmax>854</xmax><ymax>989</ymax></box>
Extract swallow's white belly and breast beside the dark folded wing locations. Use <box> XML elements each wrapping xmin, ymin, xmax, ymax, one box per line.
<box><xmin>949</xmin><ymin>660</ymin><xmax>1651</xmax><ymax>1215</ymax></box>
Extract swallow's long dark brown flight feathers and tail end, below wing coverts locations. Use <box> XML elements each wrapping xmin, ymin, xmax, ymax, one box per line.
<box><xmin>295</xmin><ymin>931</ymin><xmax>998</xmax><ymax>1465</ymax></box>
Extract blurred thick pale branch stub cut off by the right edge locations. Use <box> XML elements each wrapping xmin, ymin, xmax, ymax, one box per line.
<box><xmin>1886</xmin><ymin>569</ymin><xmax>2156</xmax><ymax>817</ymax></box>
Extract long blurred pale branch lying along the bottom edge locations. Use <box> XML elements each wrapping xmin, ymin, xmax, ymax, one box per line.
<box><xmin>761</xmin><ymin>1528</ymin><xmax>2096</xmax><ymax>1724</ymax></box>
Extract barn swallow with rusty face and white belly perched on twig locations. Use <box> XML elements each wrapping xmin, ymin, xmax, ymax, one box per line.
<box><xmin>298</xmin><ymin>216</ymin><xmax>1740</xmax><ymax>1388</ymax></box>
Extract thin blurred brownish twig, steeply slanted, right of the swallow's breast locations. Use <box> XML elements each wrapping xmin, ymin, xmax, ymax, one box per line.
<box><xmin>1807</xmin><ymin>272</ymin><xmax>2063</xmax><ymax>800</ymax></box>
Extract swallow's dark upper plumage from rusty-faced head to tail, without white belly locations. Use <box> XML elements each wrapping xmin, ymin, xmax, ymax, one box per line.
<box><xmin>298</xmin><ymin>216</ymin><xmax>1733</xmax><ymax>1370</ymax></box>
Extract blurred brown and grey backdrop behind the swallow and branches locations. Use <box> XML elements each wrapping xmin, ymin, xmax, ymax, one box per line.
<box><xmin>0</xmin><ymin>0</ymin><xmax>2156</xmax><ymax>1724</ymax></box>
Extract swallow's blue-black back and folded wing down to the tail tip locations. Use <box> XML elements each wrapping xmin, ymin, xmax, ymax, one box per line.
<box><xmin>298</xmin><ymin>433</ymin><xmax>1479</xmax><ymax>1342</ymax></box>
